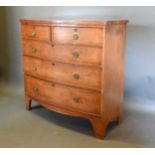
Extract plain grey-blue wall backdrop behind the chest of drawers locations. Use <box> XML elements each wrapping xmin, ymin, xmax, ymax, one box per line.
<box><xmin>0</xmin><ymin>7</ymin><xmax>155</xmax><ymax>108</ymax></box>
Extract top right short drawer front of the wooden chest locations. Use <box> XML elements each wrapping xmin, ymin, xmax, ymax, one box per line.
<box><xmin>53</xmin><ymin>27</ymin><xmax>102</xmax><ymax>46</ymax></box>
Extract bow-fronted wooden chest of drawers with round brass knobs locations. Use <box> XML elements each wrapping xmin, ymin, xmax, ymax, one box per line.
<box><xmin>20</xmin><ymin>19</ymin><xmax>127</xmax><ymax>138</ymax></box>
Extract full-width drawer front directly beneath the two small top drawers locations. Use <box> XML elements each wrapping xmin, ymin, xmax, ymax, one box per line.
<box><xmin>23</xmin><ymin>40</ymin><xmax>101</xmax><ymax>65</ymax></box>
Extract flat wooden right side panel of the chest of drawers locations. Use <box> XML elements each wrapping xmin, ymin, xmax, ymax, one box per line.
<box><xmin>102</xmin><ymin>24</ymin><xmax>126</xmax><ymax>123</ymax></box>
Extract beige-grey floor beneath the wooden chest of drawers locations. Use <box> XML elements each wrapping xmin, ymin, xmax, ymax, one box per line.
<box><xmin>0</xmin><ymin>83</ymin><xmax>155</xmax><ymax>147</ymax></box>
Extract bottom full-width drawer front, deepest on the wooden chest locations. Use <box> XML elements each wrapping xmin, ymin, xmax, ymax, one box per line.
<box><xmin>25</xmin><ymin>76</ymin><xmax>101</xmax><ymax>114</ymax></box>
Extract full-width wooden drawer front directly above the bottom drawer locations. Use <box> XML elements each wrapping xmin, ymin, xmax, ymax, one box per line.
<box><xmin>24</xmin><ymin>56</ymin><xmax>101</xmax><ymax>89</ymax></box>
